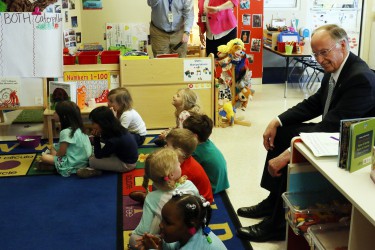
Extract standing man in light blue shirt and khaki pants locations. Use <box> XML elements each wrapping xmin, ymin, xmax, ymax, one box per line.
<box><xmin>147</xmin><ymin>0</ymin><xmax>194</xmax><ymax>57</ymax></box>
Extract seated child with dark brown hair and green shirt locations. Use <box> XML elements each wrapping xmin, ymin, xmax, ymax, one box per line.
<box><xmin>183</xmin><ymin>114</ymin><xmax>229</xmax><ymax>194</ymax></box>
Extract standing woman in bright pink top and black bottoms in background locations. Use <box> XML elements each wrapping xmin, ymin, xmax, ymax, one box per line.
<box><xmin>197</xmin><ymin>0</ymin><xmax>238</xmax><ymax>57</ymax></box>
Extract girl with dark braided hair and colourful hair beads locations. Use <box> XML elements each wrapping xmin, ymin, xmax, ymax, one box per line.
<box><xmin>138</xmin><ymin>191</ymin><xmax>227</xmax><ymax>250</ymax></box>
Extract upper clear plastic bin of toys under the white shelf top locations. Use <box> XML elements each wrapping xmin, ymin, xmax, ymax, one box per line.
<box><xmin>282</xmin><ymin>191</ymin><xmax>351</xmax><ymax>235</ymax></box>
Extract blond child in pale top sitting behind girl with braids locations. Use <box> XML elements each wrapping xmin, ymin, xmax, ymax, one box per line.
<box><xmin>129</xmin><ymin>148</ymin><xmax>199</xmax><ymax>249</ymax></box>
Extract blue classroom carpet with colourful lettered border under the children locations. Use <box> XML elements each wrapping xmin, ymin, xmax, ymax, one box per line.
<box><xmin>0</xmin><ymin>135</ymin><xmax>252</xmax><ymax>250</ymax></box>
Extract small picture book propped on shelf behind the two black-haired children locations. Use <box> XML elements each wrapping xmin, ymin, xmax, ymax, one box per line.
<box><xmin>48</xmin><ymin>81</ymin><xmax>77</xmax><ymax>110</ymax></box>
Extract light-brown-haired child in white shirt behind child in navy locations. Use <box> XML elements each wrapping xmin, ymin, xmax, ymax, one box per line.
<box><xmin>108</xmin><ymin>87</ymin><xmax>147</xmax><ymax>146</ymax></box>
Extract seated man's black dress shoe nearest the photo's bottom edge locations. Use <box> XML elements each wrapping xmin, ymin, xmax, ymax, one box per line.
<box><xmin>237</xmin><ymin>221</ymin><xmax>286</xmax><ymax>242</ymax></box>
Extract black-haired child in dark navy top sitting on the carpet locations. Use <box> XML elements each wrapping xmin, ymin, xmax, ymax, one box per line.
<box><xmin>77</xmin><ymin>106</ymin><xmax>138</xmax><ymax>178</ymax></box>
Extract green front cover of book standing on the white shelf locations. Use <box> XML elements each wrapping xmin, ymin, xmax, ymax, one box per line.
<box><xmin>347</xmin><ymin>118</ymin><xmax>375</xmax><ymax>173</ymax></box>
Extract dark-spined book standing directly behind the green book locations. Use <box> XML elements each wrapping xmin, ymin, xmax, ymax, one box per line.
<box><xmin>337</xmin><ymin>117</ymin><xmax>371</xmax><ymax>169</ymax></box>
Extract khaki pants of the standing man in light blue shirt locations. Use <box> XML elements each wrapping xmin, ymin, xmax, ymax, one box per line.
<box><xmin>150</xmin><ymin>23</ymin><xmax>187</xmax><ymax>57</ymax></box>
